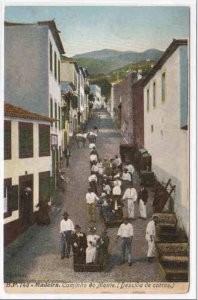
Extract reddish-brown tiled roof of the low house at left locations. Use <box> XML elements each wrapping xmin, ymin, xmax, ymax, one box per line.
<box><xmin>4</xmin><ymin>102</ymin><xmax>55</xmax><ymax>122</ymax></box>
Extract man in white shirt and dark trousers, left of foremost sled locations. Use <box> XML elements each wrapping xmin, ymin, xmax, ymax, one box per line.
<box><xmin>60</xmin><ymin>212</ymin><xmax>74</xmax><ymax>259</ymax></box>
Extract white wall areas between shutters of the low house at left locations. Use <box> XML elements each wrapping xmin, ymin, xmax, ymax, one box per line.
<box><xmin>4</xmin><ymin>118</ymin><xmax>51</xmax><ymax>224</ymax></box>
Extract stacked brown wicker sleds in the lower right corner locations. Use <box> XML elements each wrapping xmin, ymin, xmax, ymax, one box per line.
<box><xmin>153</xmin><ymin>213</ymin><xmax>189</xmax><ymax>282</ymax></box>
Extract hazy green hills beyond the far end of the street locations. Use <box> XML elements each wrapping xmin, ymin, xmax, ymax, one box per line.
<box><xmin>73</xmin><ymin>49</ymin><xmax>163</xmax><ymax>76</ymax></box>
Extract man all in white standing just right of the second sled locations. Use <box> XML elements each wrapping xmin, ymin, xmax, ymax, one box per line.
<box><xmin>122</xmin><ymin>182</ymin><xmax>137</xmax><ymax>219</ymax></box>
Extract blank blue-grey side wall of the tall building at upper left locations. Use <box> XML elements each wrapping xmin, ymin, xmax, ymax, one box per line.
<box><xmin>4</xmin><ymin>25</ymin><xmax>49</xmax><ymax>115</ymax></box>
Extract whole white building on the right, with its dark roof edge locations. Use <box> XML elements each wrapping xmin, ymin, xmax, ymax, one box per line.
<box><xmin>144</xmin><ymin>40</ymin><xmax>189</xmax><ymax>235</ymax></box>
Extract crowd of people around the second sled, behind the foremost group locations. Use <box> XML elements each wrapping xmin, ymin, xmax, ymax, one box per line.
<box><xmin>86</xmin><ymin>143</ymin><xmax>148</xmax><ymax>222</ymax></box>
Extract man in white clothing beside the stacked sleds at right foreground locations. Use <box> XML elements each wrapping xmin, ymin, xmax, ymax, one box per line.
<box><xmin>145</xmin><ymin>217</ymin><xmax>157</xmax><ymax>262</ymax></box>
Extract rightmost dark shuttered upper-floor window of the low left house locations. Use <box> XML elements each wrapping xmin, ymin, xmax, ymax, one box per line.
<box><xmin>39</xmin><ymin>124</ymin><xmax>50</xmax><ymax>156</ymax></box>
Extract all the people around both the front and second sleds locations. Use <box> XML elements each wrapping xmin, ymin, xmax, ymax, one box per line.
<box><xmin>60</xmin><ymin>123</ymin><xmax>156</xmax><ymax>266</ymax></box>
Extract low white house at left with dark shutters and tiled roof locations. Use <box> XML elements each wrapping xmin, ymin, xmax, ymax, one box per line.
<box><xmin>4</xmin><ymin>103</ymin><xmax>52</xmax><ymax>244</ymax></box>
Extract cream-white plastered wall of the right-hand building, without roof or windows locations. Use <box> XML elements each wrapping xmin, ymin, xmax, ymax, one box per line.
<box><xmin>144</xmin><ymin>49</ymin><xmax>189</xmax><ymax>234</ymax></box>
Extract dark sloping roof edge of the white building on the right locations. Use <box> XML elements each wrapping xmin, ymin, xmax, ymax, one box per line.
<box><xmin>144</xmin><ymin>39</ymin><xmax>188</xmax><ymax>85</ymax></box>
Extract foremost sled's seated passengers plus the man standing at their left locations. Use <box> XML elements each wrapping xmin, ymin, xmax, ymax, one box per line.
<box><xmin>60</xmin><ymin>212</ymin><xmax>109</xmax><ymax>264</ymax></box>
